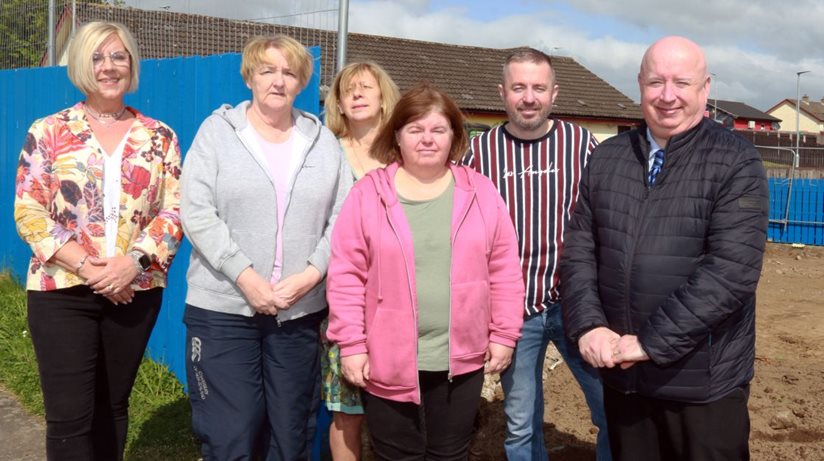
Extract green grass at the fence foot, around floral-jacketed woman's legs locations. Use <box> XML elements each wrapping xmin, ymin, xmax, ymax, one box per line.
<box><xmin>0</xmin><ymin>273</ymin><xmax>199</xmax><ymax>461</ymax></box>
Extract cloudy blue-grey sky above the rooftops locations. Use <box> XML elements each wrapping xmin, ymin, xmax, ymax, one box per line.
<box><xmin>126</xmin><ymin>0</ymin><xmax>824</xmax><ymax>111</ymax></box>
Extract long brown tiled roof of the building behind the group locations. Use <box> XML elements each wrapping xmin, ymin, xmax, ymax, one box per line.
<box><xmin>77</xmin><ymin>3</ymin><xmax>642</xmax><ymax>121</ymax></box>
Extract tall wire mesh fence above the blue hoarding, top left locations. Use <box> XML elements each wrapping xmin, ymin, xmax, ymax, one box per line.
<box><xmin>0</xmin><ymin>0</ymin><xmax>339</xmax><ymax>75</ymax></box>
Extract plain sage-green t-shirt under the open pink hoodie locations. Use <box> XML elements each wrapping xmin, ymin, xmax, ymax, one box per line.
<box><xmin>399</xmin><ymin>180</ymin><xmax>455</xmax><ymax>371</ymax></box>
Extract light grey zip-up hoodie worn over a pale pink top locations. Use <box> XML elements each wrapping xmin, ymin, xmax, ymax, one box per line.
<box><xmin>180</xmin><ymin>101</ymin><xmax>352</xmax><ymax>321</ymax></box>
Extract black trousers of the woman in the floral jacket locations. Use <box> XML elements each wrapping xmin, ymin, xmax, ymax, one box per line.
<box><xmin>28</xmin><ymin>286</ymin><xmax>163</xmax><ymax>461</ymax></box>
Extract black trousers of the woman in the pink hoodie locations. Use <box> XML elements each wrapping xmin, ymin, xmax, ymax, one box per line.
<box><xmin>363</xmin><ymin>369</ymin><xmax>484</xmax><ymax>461</ymax></box>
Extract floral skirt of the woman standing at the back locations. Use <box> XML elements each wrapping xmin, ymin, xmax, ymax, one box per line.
<box><xmin>320</xmin><ymin>319</ymin><xmax>363</xmax><ymax>415</ymax></box>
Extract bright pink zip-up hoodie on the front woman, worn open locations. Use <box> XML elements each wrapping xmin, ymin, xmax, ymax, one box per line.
<box><xmin>326</xmin><ymin>163</ymin><xmax>524</xmax><ymax>404</ymax></box>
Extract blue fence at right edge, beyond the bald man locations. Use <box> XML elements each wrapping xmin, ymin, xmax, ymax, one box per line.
<box><xmin>767</xmin><ymin>178</ymin><xmax>824</xmax><ymax>245</ymax></box>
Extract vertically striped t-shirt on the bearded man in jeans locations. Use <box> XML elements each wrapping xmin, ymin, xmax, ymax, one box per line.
<box><xmin>463</xmin><ymin>120</ymin><xmax>597</xmax><ymax>315</ymax></box>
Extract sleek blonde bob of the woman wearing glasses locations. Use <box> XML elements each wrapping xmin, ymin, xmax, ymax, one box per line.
<box><xmin>66</xmin><ymin>21</ymin><xmax>140</xmax><ymax>96</ymax></box>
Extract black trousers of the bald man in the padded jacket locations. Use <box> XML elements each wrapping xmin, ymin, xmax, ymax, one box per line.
<box><xmin>604</xmin><ymin>386</ymin><xmax>750</xmax><ymax>461</ymax></box>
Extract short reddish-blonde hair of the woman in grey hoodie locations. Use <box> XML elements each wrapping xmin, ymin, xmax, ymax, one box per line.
<box><xmin>240</xmin><ymin>35</ymin><xmax>313</xmax><ymax>88</ymax></box>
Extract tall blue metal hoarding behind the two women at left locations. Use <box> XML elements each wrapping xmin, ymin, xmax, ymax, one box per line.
<box><xmin>0</xmin><ymin>47</ymin><xmax>320</xmax><ymax>384</ymax></box>
